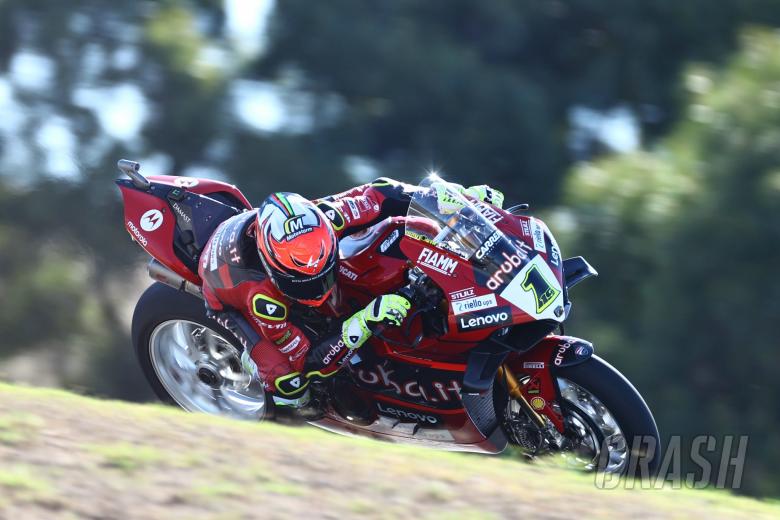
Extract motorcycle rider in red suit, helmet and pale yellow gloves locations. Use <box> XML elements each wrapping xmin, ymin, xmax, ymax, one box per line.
<box><xmin>199</xmin><ymin>178</ymin><xmax>504</xmax><ymax>418</ymax></box>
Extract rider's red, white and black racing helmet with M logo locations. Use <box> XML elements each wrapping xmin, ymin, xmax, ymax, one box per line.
<box><xmin>256</xmin><ymin>192</ymin><xmax>338</xmax><ymax>307</ymax></box>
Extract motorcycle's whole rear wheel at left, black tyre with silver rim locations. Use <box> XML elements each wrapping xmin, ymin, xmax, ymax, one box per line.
<box><xmin>132</xmin><ymin>282</ymin><xmax>266</xmax><ymax>421</ymax></box>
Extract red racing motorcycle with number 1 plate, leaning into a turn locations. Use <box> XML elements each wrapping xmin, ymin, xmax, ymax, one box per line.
<box><xmin>116</xmin><ymin>160</ymin><xmax>661</xmax><ymax>474</ymax></box>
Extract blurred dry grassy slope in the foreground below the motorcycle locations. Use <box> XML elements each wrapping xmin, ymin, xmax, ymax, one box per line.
<box><xmin>0</xmin><ymin>384</ymin><xmax>780</xmax><ymax>519</ymax></box>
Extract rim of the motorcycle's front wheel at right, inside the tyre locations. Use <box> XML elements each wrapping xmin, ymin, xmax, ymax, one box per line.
<box><xmin>558</xmin><ymin>378</ymin><xmax>628</xmax><ymax>474</ymax></box>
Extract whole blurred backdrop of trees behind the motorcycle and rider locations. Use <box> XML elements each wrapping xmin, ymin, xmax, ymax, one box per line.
<box><xmin>0</xmin><ymin>0</ymin><xmax>780</xmax><ymax>494</ymax></box>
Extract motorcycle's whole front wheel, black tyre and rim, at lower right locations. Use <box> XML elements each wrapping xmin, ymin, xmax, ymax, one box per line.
<box><xmin>505</xmin><ymin>356</ymin><xmax>661</xmax><ymax>477</ymax></box>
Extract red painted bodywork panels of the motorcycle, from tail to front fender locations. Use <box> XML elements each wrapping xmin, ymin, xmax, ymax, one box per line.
<box><xmin>120</xmin><ymin>176</ymin><xmax>574</xmax><ymax>453</ymax></box>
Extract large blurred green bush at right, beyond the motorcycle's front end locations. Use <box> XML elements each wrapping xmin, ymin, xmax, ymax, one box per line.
<box><xmin>565</xmin><ymin>29</ymin><xmax>780</xmax><ymax>494</ymax></box>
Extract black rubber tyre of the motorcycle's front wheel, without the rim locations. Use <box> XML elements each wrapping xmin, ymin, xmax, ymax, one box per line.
<box><xmin>556</xmin><ymin>356</ymin><xmax>661</xmax><ymax>477</ymax></box>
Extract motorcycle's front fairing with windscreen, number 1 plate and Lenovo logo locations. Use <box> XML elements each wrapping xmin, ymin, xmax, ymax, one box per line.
<box><xmin>402</xmin><ymin>180</ymin><xmax>565</xmax><ymax>334</ymax></box>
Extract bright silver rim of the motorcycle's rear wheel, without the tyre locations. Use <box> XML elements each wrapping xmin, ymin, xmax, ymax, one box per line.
<box><xmin>149</xmin><ymin>320</ymin><xmax>265</xmax><ymax>421</ymax></box>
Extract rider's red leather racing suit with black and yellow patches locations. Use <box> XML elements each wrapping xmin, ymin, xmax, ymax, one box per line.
<box><xmin>198</xmin><ymin>178</ymin><xmax>416</xmax><ymax>399</ymax></box>
